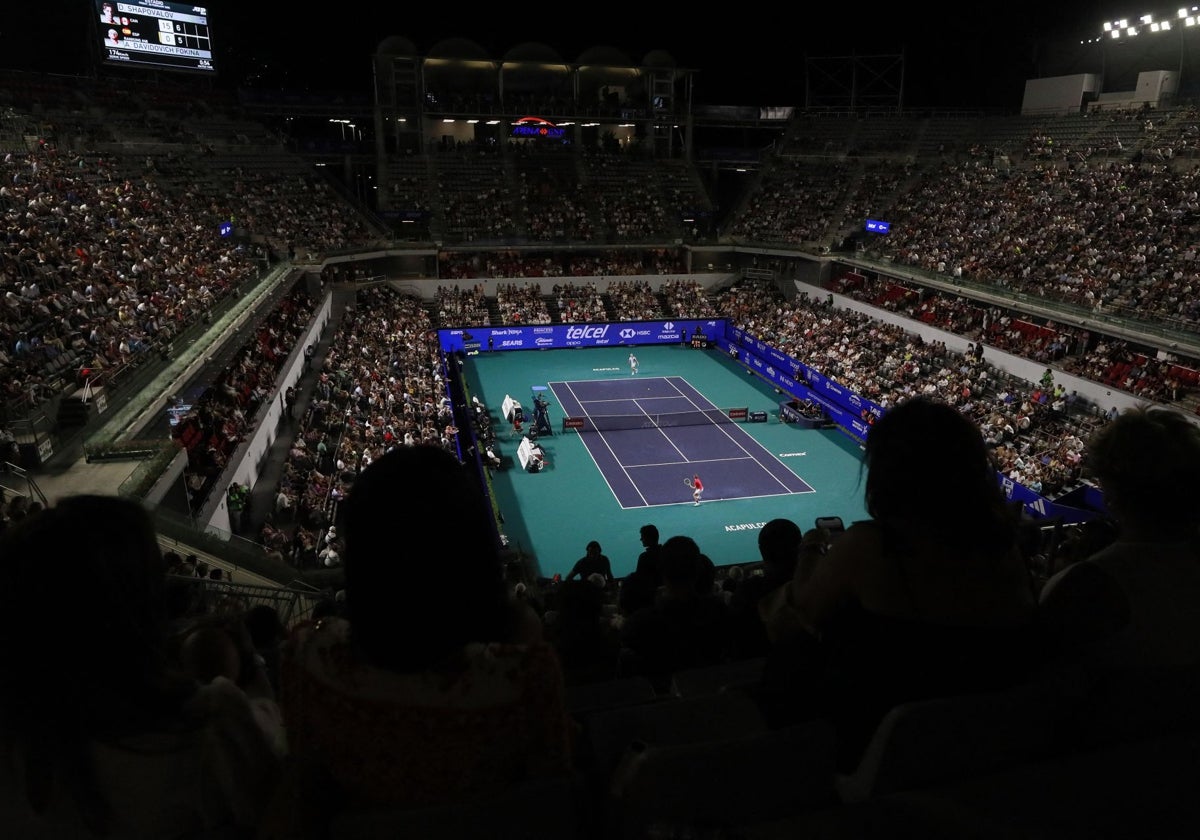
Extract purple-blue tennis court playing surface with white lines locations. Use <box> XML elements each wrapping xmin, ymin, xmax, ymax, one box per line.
<box><xmin>550</xmin><ymin>376</ymin><xmax>814</xmax><ymax>508</ymax></box>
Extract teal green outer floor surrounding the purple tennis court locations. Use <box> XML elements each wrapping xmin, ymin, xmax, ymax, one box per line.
<box><xmin>464</xmin><ymin>344</ymin><xmax>866</xmax><ymax>576</ymax></box>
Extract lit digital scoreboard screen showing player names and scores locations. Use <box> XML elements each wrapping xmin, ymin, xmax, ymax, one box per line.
<box><xmin>95</xmin><ymin>0</ymin><xmax>216</xmax><ymax>74</ymax></box>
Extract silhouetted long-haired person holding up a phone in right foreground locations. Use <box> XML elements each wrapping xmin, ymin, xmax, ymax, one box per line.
<box><xmin>762</xmin><ymin>397</ymin><xmax>1042</xmax><ymax>769</ymax></box>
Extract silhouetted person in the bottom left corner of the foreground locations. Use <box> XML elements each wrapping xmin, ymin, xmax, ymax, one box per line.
<box><xmin>0</xmin><ymin>496</ymin><xmax>280</xmax><ymax>839</ymax></box>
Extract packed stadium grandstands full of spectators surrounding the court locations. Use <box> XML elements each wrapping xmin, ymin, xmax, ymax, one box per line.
<box><xmin>0</xmin><ymin>37</ymin><xmax>1200</xmax><ymax>835</ymax></box>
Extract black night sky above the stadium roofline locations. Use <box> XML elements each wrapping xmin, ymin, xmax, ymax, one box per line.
<box><xmin>0</xmin><ymin>0</ymin><xmax>1140</xmax><ymax>108</ymax></box>
